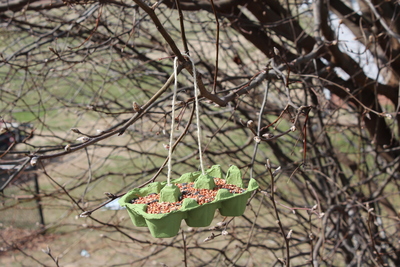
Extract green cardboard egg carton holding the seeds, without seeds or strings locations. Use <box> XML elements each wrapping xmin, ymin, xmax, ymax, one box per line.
<box><xmin>119</xmin><ymin>165</ymin><xmax>258</xmax><ymax>238</ymax></box>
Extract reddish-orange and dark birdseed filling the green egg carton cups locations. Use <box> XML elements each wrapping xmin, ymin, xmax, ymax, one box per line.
<box><xmin>132</xmin><ymin>178</ymin><xmax>246</xmax><ymax>214</ymax></box>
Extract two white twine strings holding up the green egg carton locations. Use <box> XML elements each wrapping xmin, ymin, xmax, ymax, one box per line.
<box><xmin>167</xmin><ymin>55</ymin><xmax>205</xmax><ymax>185</ymax></box>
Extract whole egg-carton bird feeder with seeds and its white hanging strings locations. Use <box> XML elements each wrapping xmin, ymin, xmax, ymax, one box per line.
<box><xmin>119</xmin><ymin>57</ymin><xmax>258</xmax><ymax>238</ymax></box>
